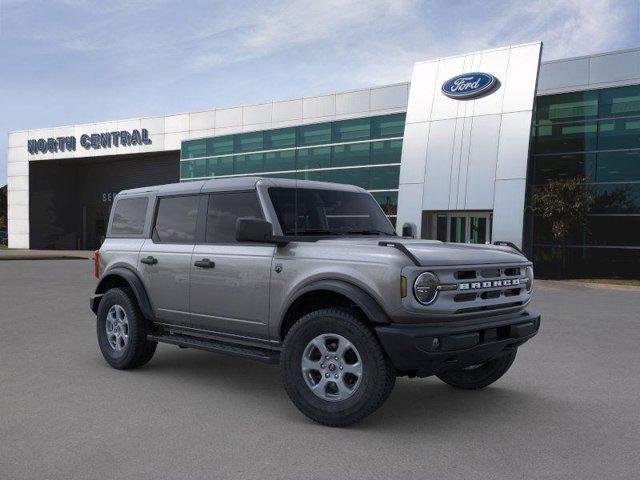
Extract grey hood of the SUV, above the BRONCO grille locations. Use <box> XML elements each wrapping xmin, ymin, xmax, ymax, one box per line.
<box><xmin>318</xmin><ymin>237</ymin><xmax>528</xmax><ymax>267</ymax></box>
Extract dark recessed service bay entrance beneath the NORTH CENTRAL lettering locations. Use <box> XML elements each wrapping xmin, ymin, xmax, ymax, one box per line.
<box><xmin>29</xmin><ymin>152</ymin><xmax>179</xmax><ymax>250</ymax></box>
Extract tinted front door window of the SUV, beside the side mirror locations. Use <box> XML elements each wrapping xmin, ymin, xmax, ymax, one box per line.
<box><xmin>206</xmin><ymin>192</ymin><xmax>262</xmax><ymax>243</ymax></box>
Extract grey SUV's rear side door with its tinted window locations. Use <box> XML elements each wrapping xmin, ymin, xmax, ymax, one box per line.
<box><xmin>138</xmin><ymin>195</ymin><xmax>204</xmax><ymax>325</ymax></box>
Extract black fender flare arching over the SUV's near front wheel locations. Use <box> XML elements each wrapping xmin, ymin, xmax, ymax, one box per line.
<box><xmin>280</xmin><ymin>279</ymin><xmax>391</xmax><ymax>325</ymax></box>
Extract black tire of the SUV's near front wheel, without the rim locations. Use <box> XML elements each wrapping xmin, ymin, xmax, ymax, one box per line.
<box><xmin>280</xmin><ymin>308</ymin><xmax>396</xmax><ymax>427</ymax></box>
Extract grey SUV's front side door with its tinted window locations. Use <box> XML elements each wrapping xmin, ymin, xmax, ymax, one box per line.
<box><xmin>190</xmin><ymin>191</ymin><xmax>275</xmax><ymax>340</ymax></box>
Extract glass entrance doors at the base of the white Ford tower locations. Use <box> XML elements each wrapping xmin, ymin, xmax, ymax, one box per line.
<box><xmin>432</xmin><ymin>212</ymin><xmax>492</xmax><ymax>243</ymax></box>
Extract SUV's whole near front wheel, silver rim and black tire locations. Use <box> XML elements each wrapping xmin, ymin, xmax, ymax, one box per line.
<box><xmin>280</xmin><ymin>308</ymin><xmax>396</xmax><ymax>427</ymax></box>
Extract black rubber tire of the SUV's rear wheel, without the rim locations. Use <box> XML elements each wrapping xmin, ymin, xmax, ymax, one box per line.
<box><xmin>96</xmin><ymin>288</ymin><xmax>158</xmax><ymax>370</ymax></box>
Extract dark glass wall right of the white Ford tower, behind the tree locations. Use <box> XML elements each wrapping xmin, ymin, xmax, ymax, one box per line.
<box><xmin>525</xmin><ymin>85</ymin><xmax>640</xmax><ymax>278</ymax></box>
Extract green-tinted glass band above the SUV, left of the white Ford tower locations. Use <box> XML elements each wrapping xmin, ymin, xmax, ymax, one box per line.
<box><xmin>180</xmin><ymin>113</ymin><xmax>405</xmax><ymax>224</ymax></box>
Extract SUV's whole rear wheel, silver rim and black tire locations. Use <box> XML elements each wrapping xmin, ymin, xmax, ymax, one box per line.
<box><xmin>96</xmin><ymin>288</ymin><xmax>158</xmax><ymax>369</ymax></box>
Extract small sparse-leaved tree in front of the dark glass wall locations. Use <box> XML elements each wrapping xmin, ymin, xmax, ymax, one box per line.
<box><xmin>534</xmin><ymin>177</ymin><xmax>589</xmax><ymax>277</ymax></box>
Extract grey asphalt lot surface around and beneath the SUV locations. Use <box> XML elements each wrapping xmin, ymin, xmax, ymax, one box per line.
<box><xmin>0</xmin><ymin>260</ymin><xmax>640</xmax><ymax>480</ymax></box>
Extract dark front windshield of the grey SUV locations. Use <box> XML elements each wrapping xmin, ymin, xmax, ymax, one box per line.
<box><xmin>269</xmin><ymin>187</ymin><xmax>395</xmax><ymax>235</ymax></box>
